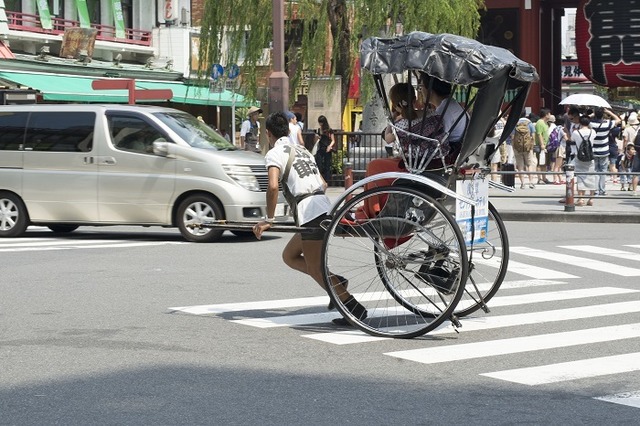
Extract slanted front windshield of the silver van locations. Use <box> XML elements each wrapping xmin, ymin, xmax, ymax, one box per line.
<box><xmin>154</xmin><ymin>112</ymin><xmax>238</xmax><ymax>151</ymax></box>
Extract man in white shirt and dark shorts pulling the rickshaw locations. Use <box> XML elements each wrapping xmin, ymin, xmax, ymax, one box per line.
<box><xmin>253</xmin><ymin>112</ymin><xmax>367</xmax><ymax>325</ymax></box>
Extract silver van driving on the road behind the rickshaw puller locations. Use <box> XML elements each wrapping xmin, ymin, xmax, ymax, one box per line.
<box><xmin>0</xmin><ymin>104</ymin><xmax>285</xmax><ymax>242</ymax></box>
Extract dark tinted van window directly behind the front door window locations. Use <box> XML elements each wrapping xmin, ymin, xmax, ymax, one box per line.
<box><xmin>24</xmin><ymin>111</ymin><xmax>96</xmax><ymax>152</ymax></box>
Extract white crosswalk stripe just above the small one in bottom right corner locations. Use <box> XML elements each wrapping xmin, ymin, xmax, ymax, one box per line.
<box><xmin>480</xmin><ymin>352</ymin><xmax>640</xmax><ymax>386</ymax></box>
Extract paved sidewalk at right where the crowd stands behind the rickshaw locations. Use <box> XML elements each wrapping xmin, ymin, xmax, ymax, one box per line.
<box><xmin>327</xmin><ymin>180</ymin><xmax>640</xmax><ymax>223</ymax></box>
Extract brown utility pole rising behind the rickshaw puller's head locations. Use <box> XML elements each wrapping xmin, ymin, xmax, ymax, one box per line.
<box><xmin>269</xmin><ymin>0</ymin><xmax>289</xmax><ymax>113</ymax></box>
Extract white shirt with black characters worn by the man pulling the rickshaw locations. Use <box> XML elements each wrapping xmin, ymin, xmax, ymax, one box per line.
<box><xmin>265</xmin><ymin>137</ymin><xmax>331</xmax><ymax>225</ymax></box>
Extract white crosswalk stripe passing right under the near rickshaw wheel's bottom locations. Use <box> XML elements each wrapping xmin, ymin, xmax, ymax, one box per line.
<box><xmin>302</xmin><ymin>301</ymin><xmax>640</xmax><ymax>345</ymax></box>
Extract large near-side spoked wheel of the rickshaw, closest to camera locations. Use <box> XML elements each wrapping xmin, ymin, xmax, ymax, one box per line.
<box><xmin>322</xmin><ymin>186</ymin><xmax>468</xmax><ymax>338</ymax></box>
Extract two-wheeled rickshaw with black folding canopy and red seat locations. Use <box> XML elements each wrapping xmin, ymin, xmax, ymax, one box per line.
<box><xmin>202</xmin><ymin>32</ymin><xmax>538</xmax><ymax>338</ymax></box>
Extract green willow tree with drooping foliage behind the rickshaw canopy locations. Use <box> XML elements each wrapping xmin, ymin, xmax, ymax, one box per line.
<box><xmin>199</xmin><ymin>0</ymin><xmax>484</xmax><ymax>111</ymax></box>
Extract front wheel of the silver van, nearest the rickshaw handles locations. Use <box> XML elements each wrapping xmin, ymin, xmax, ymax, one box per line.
<box><xmin>177</xmin><ymin>195</ymin><xmax>224</xmax><ymax>243</ymax></box>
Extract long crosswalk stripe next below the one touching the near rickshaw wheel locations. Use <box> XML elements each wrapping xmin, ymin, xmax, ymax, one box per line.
<box><xmin>385</xmin><ymin>323</ymin><xmax>640</xmax><ymax>364</ymax></box>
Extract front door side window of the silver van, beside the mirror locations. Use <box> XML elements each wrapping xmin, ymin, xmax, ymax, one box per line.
<box><xmin>109</xmin><ymin>114</ymin><xmax>167</xmax><ymax>154</ymax></box>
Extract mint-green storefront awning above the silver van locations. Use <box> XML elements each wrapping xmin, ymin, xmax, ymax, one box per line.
<box><xmin>0</xmin><ymin>71</ymin><xmax>251</xmax><ymax>107</ymax></box>
